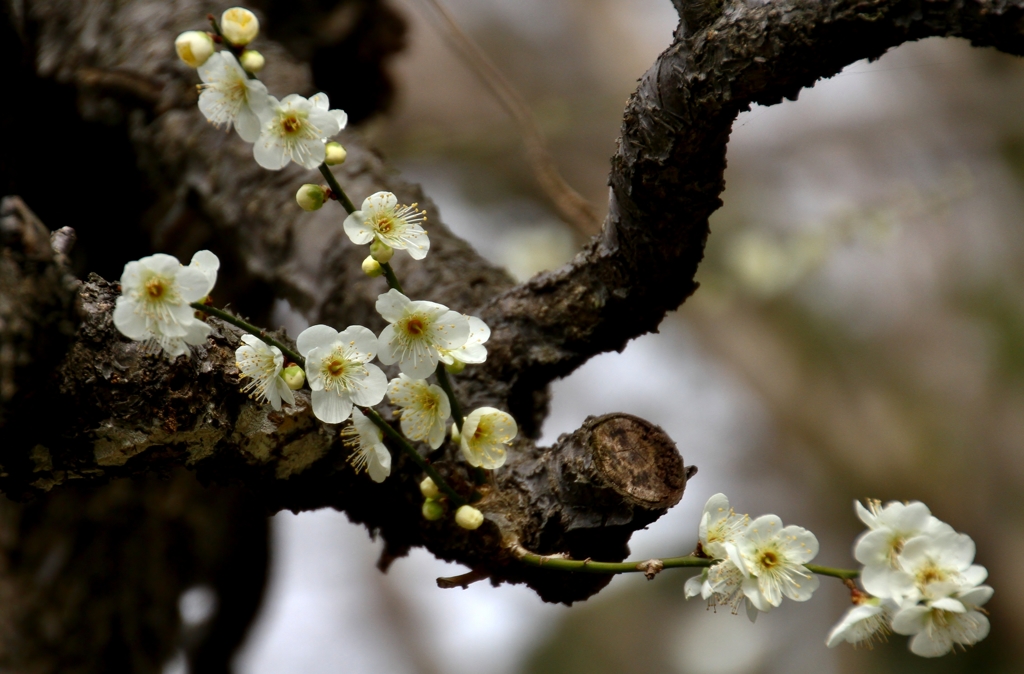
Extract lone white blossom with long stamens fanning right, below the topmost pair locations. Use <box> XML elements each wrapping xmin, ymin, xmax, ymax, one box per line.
<box><xmin>344</xmin><ymin>192</ymin><xmax>430</xmax><ymax>260</ymax></box>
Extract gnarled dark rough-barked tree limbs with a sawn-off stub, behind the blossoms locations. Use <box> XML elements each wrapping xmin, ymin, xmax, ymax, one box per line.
<box><xmin>6</xmin><ymin>0</ymin><xmax>1024</xmax><ymax>659</ymax></box>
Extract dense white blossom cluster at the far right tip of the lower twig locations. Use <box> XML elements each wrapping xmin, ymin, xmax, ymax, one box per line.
<box><xmin>826</xmin><ymin>501</ymin><xmax>993</xmax><ymax>658</ymax></box>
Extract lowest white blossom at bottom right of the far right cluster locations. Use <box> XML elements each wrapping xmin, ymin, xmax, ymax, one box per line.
<box><xmin>893</xmin><ymin>585</ymin><xmax>992</xmax><ymax>658</ymax></box>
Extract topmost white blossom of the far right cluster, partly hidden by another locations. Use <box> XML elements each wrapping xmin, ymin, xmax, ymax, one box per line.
<box><xmin>853</xmin><ymin>500</ymin><xmax>953</xmax><ymax>603</ymax></box>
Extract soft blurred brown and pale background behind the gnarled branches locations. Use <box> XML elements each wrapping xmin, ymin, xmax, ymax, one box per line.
<box><xmin>218</xmin><ymin>0</ymin><xmax>1024</xmax><ymax>674</ymax></box>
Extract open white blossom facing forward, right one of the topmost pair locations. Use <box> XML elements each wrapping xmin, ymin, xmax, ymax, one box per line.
<box><xmin>253</xmin><ymin>93</ymin><xmax>341</xmax><ymax>171</ymax></box>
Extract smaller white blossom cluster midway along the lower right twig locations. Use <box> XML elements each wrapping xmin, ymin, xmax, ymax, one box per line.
<box><xmin>685</xmin><ymin>494</ymin><xmax>818</xmax><ymax>622</ymax></box>
